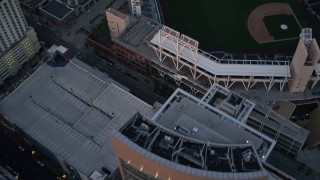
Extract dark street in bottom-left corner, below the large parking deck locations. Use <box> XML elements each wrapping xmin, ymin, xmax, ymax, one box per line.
<box><xmin>0</xmin><ymin>121</ymin><xmax>58</xmax><ymax>180</ymax></box>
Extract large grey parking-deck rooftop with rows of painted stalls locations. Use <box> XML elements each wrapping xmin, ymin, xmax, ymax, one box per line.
<box><xmin>0</xmin><ymin>59</ymin><xmax>156</xmax><ymax>176</ymax></box>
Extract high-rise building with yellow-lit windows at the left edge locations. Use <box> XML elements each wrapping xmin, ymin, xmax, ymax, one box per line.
<box><xmin>0</xmin><ymin>0</ymin><xmax>40</xmax><ymax>84</ymax></box>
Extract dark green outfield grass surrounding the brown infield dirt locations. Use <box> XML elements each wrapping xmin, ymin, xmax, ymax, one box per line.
<box><xmin>161</xmin><ymin>0</ymin><xmax>307</xmax><ymax>51</ymax></box>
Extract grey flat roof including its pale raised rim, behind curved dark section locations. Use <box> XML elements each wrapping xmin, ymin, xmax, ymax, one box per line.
<box><xmin>152</xmin><ymin>87</ymin><xmax>275</xmax><ymax>160</ymax></box>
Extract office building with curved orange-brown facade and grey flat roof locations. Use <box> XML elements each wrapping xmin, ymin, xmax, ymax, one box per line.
<box><xmin>111</xmin><ymin>85</ymin><xmax>275</xmax><ymax>179</ymax></box>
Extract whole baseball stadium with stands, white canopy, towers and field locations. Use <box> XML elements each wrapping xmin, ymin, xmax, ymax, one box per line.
<box><xmin>107</xmin><ymin>0</ymin><xmax>320</xmax><ymax>94</ymax></box>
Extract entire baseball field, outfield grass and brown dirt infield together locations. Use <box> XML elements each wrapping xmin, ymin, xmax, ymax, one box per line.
<box><xmin>160</xmin><ymin>0</ymin><xmax>308</xmax><ymax>52</ymax></box>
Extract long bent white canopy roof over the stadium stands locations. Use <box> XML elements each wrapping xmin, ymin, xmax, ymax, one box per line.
<box><xmin>150</xmin><ymin>30</ymin><xmax>291</xmax><ymax>77</ymax></box>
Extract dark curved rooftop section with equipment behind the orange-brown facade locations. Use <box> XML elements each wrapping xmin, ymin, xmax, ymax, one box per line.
<box><xmin>120</xmin><ymin>114</ymin><xmax>261</xmax><ymax>172</ymax></box>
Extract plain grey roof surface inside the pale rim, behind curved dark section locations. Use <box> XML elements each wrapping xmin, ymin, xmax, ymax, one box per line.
<box><xmin>156</xmin><ymin>95</ymin><xmax>263</xmax><ymax>148</ymax></box>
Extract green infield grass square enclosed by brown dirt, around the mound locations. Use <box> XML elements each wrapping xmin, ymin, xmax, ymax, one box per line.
<box><xmin>263</xmin><ymin>14</ymin><xmax>301</xmax><ymax>40</ymax></box>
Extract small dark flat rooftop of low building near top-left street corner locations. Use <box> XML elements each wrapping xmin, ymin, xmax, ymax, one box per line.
<box><xmin>41</xmin><ymin>0</ymin><xmax>73</xmax><ymax>19</ymax></box>
